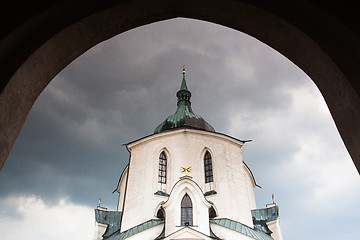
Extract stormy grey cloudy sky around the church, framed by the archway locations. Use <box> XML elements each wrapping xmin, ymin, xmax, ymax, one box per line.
<box><xmin>0</xmin><ymin>19</ymin><xmax>360</xmax><ymax>240</ymax></box>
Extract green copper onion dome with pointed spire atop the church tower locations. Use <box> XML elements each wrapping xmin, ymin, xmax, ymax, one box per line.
<box><xmin>154</xmin><ymin>68</ymin><xmax>215</xmax><ymax>133</ymax></box>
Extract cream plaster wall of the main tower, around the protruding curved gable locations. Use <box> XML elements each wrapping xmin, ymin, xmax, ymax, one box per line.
<box><xmin>121</xmin><ymin>129</ymin><xmax>254</xmax><ymax>231</ymax></box>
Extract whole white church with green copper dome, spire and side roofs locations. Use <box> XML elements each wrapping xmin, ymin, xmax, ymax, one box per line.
<box><xmin>95</xmin><ymin>68</ymin><xmax>282</xmax><ymax>240</ymax></box>
